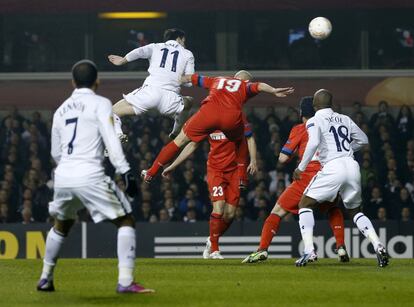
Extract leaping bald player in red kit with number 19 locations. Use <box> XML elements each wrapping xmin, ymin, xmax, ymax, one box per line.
<box><xmin>142</xmin><ymin>70</ymin><xmax>293</xmax><ymax>182</ymax></box>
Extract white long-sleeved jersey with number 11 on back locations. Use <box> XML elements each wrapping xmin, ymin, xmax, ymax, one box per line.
<box><xmin>125</xmin><ymin>40</ymin><xmax>194</xmax><ymax>93</ymax></box>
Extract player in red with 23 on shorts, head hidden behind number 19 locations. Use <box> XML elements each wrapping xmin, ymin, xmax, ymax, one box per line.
<box><xmin>163</xmin><ymin>116</ymin><xmax>257</xmax><ymax>259</ymax></box>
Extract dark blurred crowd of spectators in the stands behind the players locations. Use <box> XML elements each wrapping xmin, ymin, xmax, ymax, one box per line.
<box><xmin>0</xmin><ymin>101</ymin><xmax>414</xmax><ymax>224</ymax></box>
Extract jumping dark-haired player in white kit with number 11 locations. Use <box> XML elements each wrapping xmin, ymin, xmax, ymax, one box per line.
<box><xmin>108</xmin><ymin>28</ymin><xmax>194</xmax><ymax>138</ymax></box>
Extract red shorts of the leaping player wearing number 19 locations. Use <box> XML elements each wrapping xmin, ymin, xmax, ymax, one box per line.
<box><xmin>183</xmin><ymin>102</ymin><xmax>244</xmax><ymax>143</ymax></box>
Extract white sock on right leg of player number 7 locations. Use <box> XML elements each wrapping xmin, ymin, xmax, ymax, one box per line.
<box><xmin>118</xmin><ymin>226</ymin><xmax>136</xmax><ymax>287</ymax></box>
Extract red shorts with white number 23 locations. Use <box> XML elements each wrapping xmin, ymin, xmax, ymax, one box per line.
<box><xmin>207</xmin><ymin>168</ymin><xmax>240</xmax><ymax>206</ymax></box>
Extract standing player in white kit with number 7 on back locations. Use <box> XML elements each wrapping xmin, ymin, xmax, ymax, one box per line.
<box><xmin>37</xmin><ymin>60</ymin><xmax>154</xmax><ymax>293</ymax></box>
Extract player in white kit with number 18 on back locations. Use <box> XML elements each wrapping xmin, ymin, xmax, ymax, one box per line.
<box><xmin>293</xmin><ymin>89</ymin><xmax>389</xmax><ymax>267</ymax></box>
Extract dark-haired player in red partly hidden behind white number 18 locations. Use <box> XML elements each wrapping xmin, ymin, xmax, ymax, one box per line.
<box><xmin>243</xmin><ymin>97</ymin><xmax>349</xmax><ymax>263</ymax></box>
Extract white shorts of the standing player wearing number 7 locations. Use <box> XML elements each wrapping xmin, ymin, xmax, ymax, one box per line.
<box><xmin>49</xmin><ymin>176</ymin><xmax>132</xmax><ymax>223</ymax></box>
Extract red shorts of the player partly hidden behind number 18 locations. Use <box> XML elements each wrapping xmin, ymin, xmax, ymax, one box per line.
<box><xmin>277</xmin><ymin>162</ymin><xmax>321</xmax><ymax>214</ymax></box>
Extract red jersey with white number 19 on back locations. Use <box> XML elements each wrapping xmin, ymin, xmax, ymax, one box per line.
<box><xmin>191</xmin><ymin>74</ymin><xmax>259</xmax><ymax>110</ymax></box>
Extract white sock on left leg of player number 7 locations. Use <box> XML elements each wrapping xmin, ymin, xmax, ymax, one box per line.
<box><xmin>40</xmin><ymin>227</ymin><xmax>66</xmax><ymax>280</ymax></box>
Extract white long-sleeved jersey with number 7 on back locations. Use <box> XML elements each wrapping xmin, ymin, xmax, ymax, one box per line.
<box><xmin>51</xmin><ymin>88</ymin><xmax>130</xmax><ymax>187</ymax></box>
